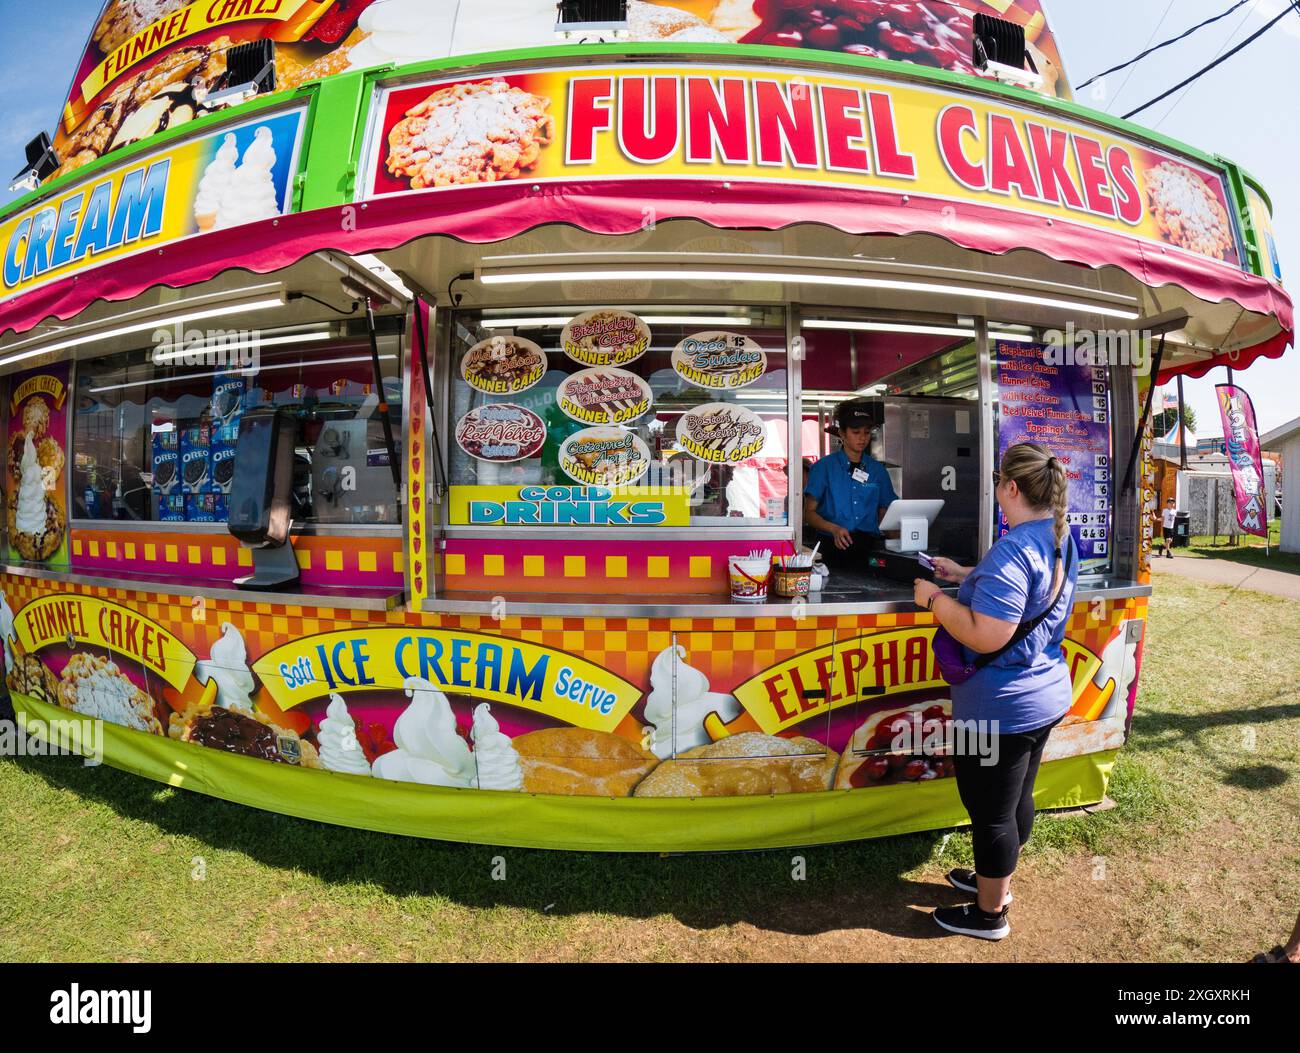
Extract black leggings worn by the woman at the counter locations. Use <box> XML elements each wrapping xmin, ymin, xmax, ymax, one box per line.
<box><xmin>953</xmin><ymin>720</ymin><xmax>1058</xmax><ymax>878</ymax></box>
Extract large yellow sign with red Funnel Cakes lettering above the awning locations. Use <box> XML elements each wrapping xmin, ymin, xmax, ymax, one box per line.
<box><xmin>361</xmin><ymin>62</ymin><xmax>1242</xmax><ymax>268</ymax></box>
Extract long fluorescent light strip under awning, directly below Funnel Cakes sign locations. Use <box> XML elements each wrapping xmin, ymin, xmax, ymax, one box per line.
<box><xmin>478</xmin><ymin>268</ymin><xmax>1140</xmax><ymax>320</ymax></box>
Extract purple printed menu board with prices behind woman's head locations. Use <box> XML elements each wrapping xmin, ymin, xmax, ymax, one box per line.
<box><xmin>996</xmin><ymin>342</ymin><xmax>1112</xmax><ymax>573</ymax></box>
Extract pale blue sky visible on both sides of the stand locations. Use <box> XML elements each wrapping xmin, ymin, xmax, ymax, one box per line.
<box><xmin>0</xmin><ymin>0</ymin><xmax>1300</xmax><ymax>437</ymax></box>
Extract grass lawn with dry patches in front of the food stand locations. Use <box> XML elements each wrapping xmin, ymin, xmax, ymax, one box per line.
<box><xmin>0</xmin><ymin>579</ymin><xmax>1300</xmax><ymax>961</ymax></box>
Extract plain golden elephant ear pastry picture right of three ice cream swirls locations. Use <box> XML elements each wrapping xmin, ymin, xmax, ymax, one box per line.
<box><xmin>514</xmin><ymin>728</ymin><xmax>659</xmax><ymax>797</ymax></box>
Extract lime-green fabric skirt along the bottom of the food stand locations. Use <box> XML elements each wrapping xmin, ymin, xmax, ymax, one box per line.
<box><xmin>12</xmin><ymin>693</ymin><xmax>1117</xmax><ymax>852</ymax></box>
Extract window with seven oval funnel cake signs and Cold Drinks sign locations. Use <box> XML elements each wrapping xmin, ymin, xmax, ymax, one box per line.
<box><xmin>447</xmin><ymin>307</ymin><xmax>789</xmax><ymax>528</ymax></box>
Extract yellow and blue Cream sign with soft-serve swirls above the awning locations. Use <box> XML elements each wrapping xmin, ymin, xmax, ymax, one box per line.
<box><xmin>0</xmin><ymin>108</ymin><xmax>306</xmax><ymax>299</ymax></box>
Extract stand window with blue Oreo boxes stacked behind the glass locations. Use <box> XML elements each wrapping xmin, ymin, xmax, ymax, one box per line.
<box><xmin>72</xmin><ymin>312</ymin><xmax>403</xmax><ymax>525</ymax></box>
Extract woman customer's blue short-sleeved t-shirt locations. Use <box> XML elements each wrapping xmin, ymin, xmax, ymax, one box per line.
<box><xmin>953</xmin><ymin>519</ymin><xmax>1079</xmax><ymax>735</ymax></box>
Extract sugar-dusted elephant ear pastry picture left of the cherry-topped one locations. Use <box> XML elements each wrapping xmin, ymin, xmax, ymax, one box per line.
<box><xmin>636</xmin><ymin>732</ymin><xmax>840</xmax><ymax>797</ymax></box>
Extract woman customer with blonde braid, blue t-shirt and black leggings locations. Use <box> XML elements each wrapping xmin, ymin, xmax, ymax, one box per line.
<box><xmin>915</xmin><ymin>442</ymin><xmax>1079</xmax><ymax>940</ymax></box>
